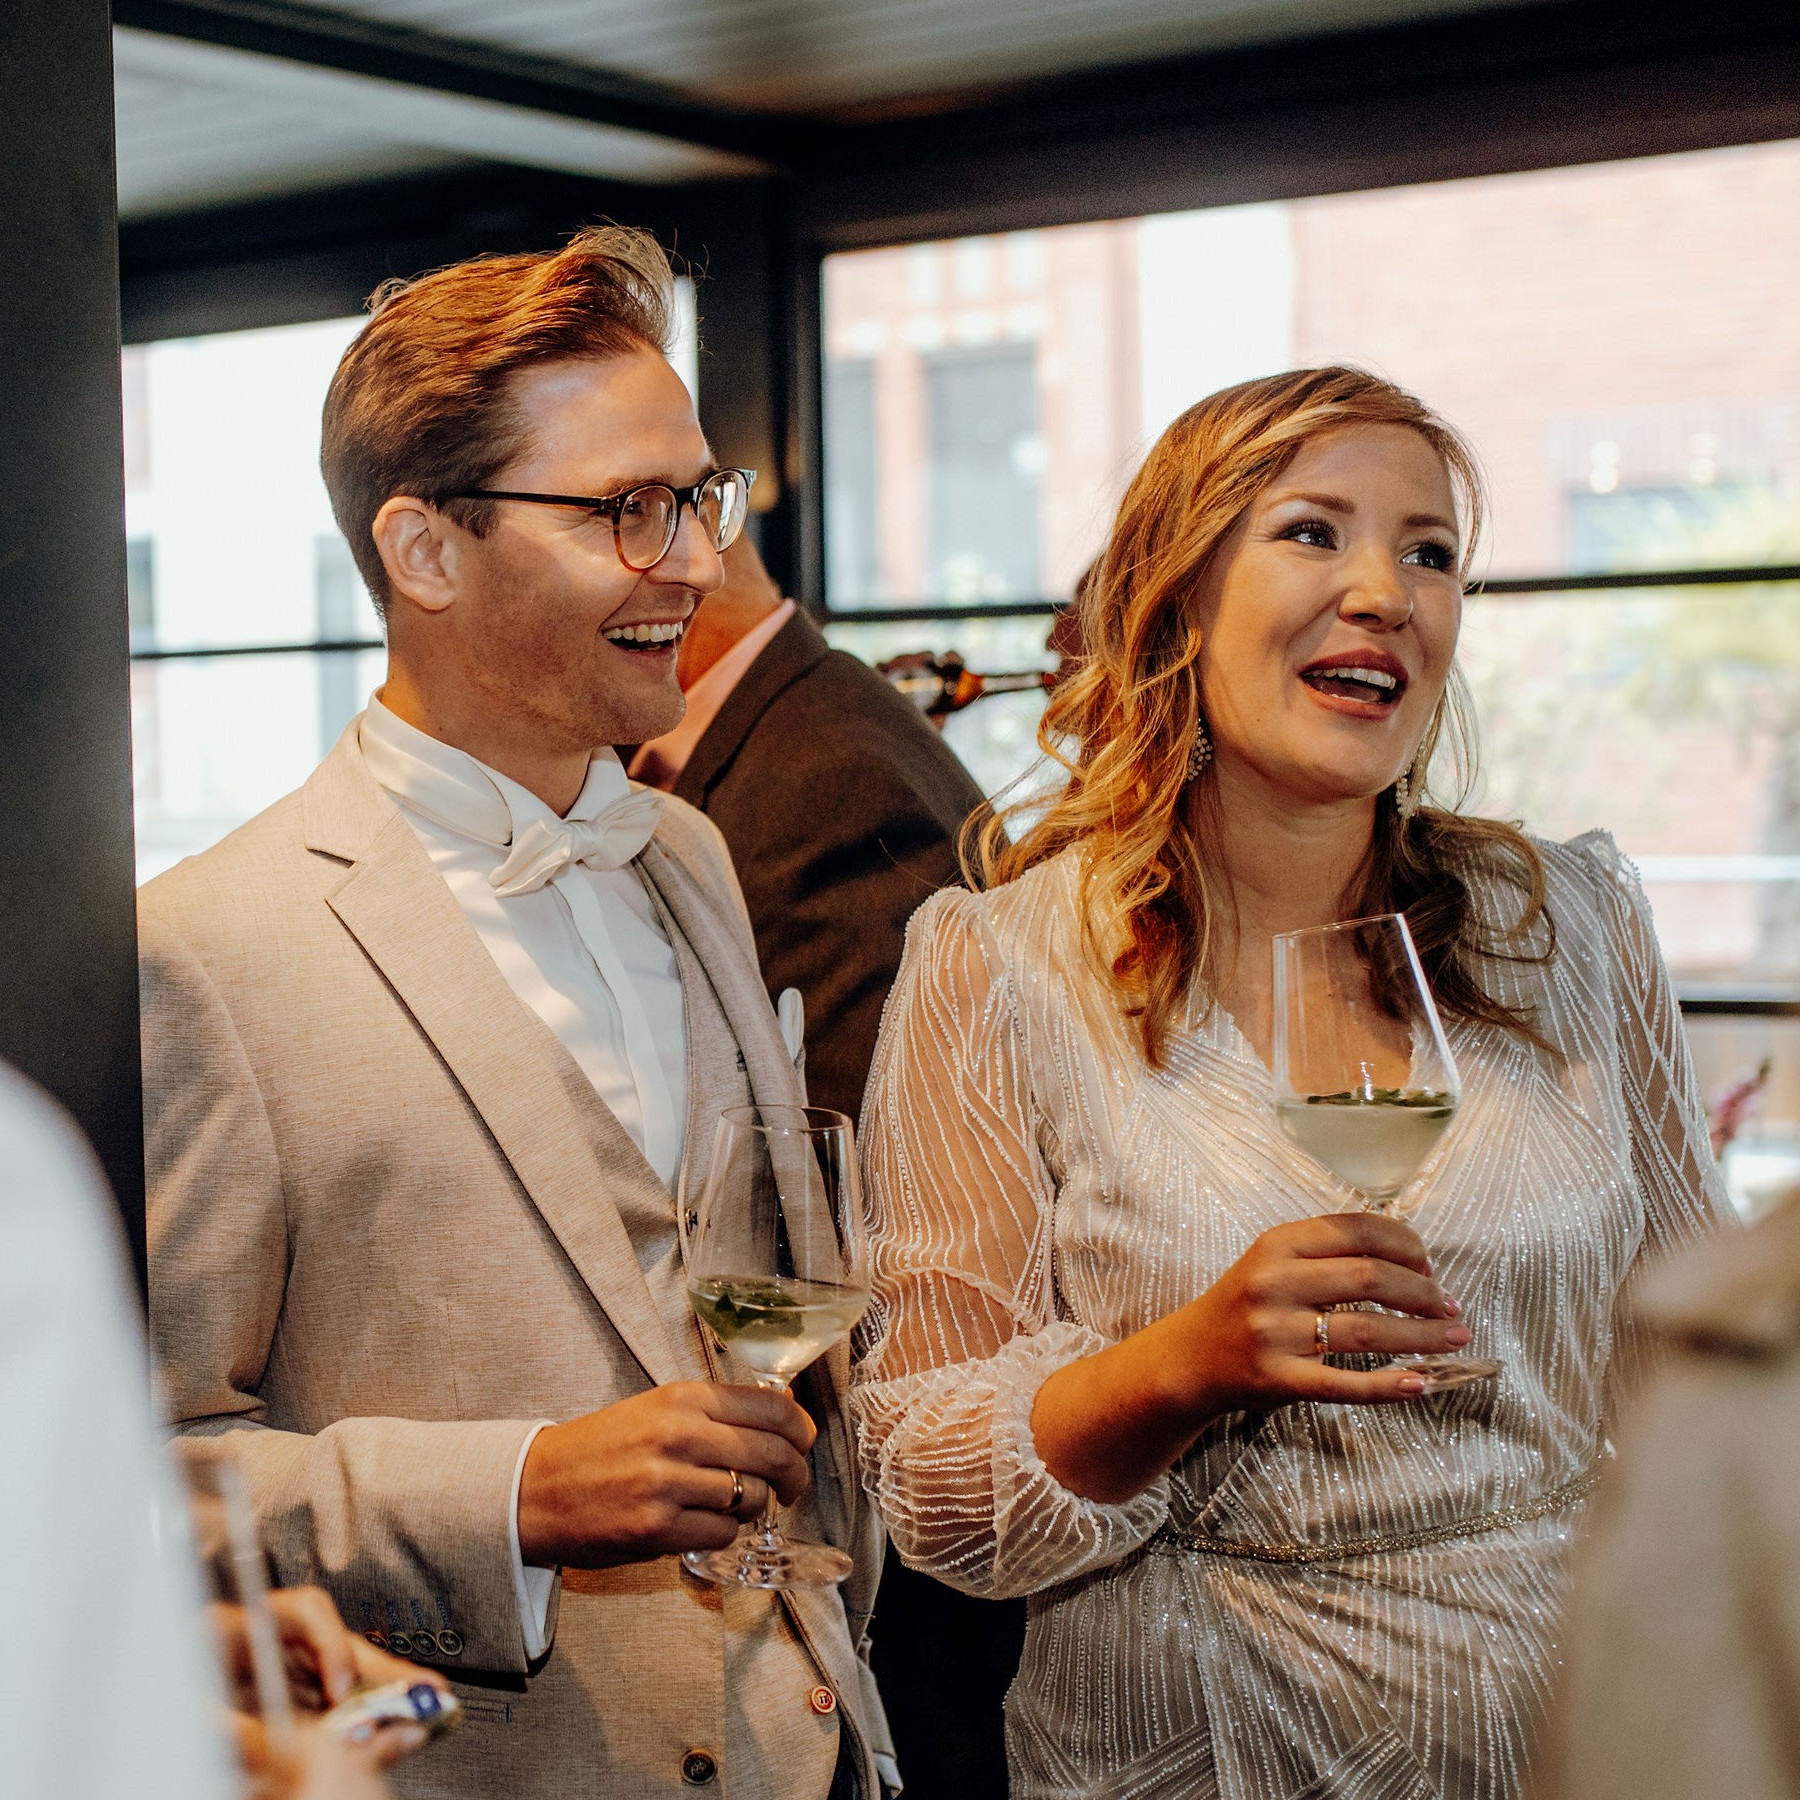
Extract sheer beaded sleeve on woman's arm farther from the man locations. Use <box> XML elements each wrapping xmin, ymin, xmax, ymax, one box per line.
<box><xmin>1570</xmin><ymin>832</ymin><xmax>1735</xmax><ymax>1384</ymax></box>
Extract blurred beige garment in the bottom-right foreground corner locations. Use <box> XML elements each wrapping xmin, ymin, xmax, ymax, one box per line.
<box><xmin>1537</xmin><ymin>1195</ymin><xmax>1800</xmax><ymax>1800</ymax></box>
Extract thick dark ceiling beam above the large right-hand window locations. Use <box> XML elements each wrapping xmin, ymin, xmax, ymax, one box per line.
<box><xmin>796</xmin><ymin>0</ymin><xmax>1800</xmax><ymax>250</ymax></box>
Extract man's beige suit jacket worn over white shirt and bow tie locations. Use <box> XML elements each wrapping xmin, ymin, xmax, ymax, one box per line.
<box><xmin>140</xmin><ymin>725</ymin><xmax>886</xmax><ymax>1800</ymax></box>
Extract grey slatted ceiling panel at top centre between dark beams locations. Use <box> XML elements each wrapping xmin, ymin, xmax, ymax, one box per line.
<box><xmin>306</xmin><ymin>0</ymin><xmax>1519</xmax><ymax>115</ymax></box>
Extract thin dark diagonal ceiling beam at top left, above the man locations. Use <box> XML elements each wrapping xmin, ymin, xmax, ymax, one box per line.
<box><xmin>112</xmin><ymin>0</ymin><xmax>787</xmax><ymax>164</ymax></box>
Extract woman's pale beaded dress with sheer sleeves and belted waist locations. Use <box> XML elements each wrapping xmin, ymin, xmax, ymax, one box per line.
<box><xmin>853</xmin><ymin>833</ymin><xmax>1726</xmax><ymax>1800</ymax></box>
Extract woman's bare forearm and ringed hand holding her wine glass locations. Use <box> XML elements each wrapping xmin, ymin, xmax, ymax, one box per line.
<box><xmin>1031</xmin><ymin>1213</ymin><xmax>1471</xmax><ymax>1505</ymax></box>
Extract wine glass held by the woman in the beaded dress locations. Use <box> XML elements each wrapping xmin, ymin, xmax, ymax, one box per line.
<box><xmin>1274</xmin><ymin>913</ymin><xmax>1505</xmax><ymax>1393</ymax></box>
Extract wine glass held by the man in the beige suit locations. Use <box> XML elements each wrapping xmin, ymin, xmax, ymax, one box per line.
<box><xmin>682</xmin><ymin>1107</ymin><xmax>869</xmax><ymax>1588</ymax></box>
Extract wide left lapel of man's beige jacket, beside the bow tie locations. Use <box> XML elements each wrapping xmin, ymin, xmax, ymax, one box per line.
<box><xmin>306</xmin><ymin>738</ymin><xmax>686</xmax><ymax>1382</ymax></box>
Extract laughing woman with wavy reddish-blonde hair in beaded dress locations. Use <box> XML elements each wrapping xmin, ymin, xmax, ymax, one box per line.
<box><xmin>855</xmin><ymin>369</ymin><xmax>1723</xmax><ymax>1800</ymax></box>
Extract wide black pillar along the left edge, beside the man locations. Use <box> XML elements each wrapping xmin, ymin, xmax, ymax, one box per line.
<box><xmin>0</xmin><ymin>0</ymin><xmax>144</xmax><ymax>1269</ymax></box>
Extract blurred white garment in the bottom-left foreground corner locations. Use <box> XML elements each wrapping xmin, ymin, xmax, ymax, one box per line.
<box><xmin>0</xmin><ymin>1067</ymin><xmax>232</xmax><ymax>1800</ymax></box>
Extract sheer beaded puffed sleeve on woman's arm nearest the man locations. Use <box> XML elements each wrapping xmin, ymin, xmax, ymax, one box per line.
<box><xmin>851</xmin><ymin>893</ymin><xmax>1168</xmax><ymax>1597</ymax></box>
